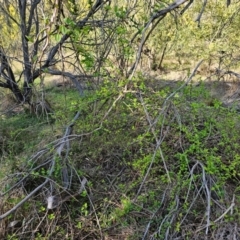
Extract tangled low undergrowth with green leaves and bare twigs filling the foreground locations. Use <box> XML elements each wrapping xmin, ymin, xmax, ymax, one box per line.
<box><xmin>0</xmin><ymin>76</ymin><xmax>240</xmax><ymax>239</ymax></box>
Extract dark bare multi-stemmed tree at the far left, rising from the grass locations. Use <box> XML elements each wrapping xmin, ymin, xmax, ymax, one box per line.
<box><xmin>0</xmin><ymin>0</ymin><xmax>107</xmax><ymax>103</ymax></box>
